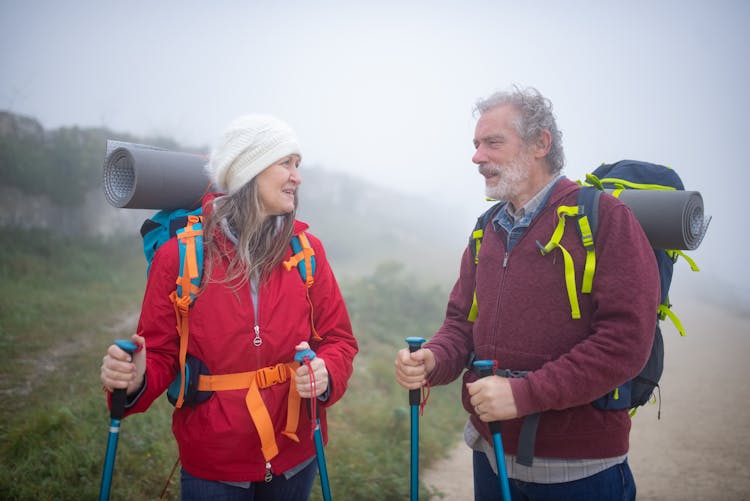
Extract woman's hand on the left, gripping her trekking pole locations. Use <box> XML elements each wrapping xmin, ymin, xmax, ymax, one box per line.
<box><xmin>99</xmin><ymin>334</ymin><xmax>146</xmax><ymax>395</ymax></box>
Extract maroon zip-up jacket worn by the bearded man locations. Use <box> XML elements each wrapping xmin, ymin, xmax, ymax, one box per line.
<box><xmin>425</xmin><ymin>178</ymin><xmax>659</xmax><ymax>458</ymax></box>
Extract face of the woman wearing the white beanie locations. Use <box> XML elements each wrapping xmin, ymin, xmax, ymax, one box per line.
<box><xmin>256</xmin><ymin>155</ymin><xmax>302</xmax><ymax>216</ymax></box>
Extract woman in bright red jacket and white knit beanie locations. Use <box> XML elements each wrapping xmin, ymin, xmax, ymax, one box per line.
<box><xmin>101</xmin><ymin>115</ymin><xmax>358</xmax><ymax>500</ymax></box>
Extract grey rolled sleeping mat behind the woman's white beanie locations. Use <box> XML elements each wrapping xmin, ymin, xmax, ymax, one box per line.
<box><xmin>104</xmin><ymin>141</ymin><xmax>211</xmax><ymax>209</ymax></box>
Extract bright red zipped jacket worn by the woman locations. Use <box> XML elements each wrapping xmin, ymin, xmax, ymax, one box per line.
<box><xmin>122</xmin><ymin>193</ymin><xmax>358</xmax><ymax>481</ymax></box>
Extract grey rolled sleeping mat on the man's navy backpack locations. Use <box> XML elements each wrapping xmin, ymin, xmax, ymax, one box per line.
<box><xmin>605</xmin><ymin>190</ymin><xmax>711</xmax><ymax>250</ymax></box>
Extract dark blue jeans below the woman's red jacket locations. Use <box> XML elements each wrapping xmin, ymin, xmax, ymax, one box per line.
<box><xmin>181</xmin><ymin>461</ymin><xmax>318</xmax><ymax>501</ymax></box>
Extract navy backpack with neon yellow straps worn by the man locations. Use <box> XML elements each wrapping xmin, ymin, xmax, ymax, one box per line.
<box><xmin>467</xmin><ymin>160</ymin><xmax>699</xmax><ymax>416</ymax></box>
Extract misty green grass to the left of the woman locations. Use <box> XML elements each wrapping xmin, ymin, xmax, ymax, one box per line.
<box><xmin>0</xmin><ymin>230</ymin><xmax>177</xmax><ymax>500</ymax></box>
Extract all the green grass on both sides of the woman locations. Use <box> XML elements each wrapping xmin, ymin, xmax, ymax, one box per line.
<box><xmin>0</xmin><ymin>229</ymin><xmax>464</xmax><ymax>500</ymax></box>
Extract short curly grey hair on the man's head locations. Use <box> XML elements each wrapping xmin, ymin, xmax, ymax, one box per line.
<box><xmin>474</xmin><ymin>86</ymin><xmax>565</xmax><ymax>174</ymax></box>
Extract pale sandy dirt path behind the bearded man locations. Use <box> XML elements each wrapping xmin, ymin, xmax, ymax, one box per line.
<box><xmin>423</xmin><ymin>298</ymin><xmax>750</xmax><ymax>501</ymax></box>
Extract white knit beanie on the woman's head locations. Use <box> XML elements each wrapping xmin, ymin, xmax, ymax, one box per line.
<box><xmin>206</xmin><ymin>115</ymin><xmax>302</xmax><ymax>195</ymax></box>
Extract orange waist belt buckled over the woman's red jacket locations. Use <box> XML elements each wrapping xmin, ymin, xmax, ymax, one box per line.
<box><xmin>198</xmin><ymin>362</ymin><xmax>301</xmax><ymax>461</ymax></box>
